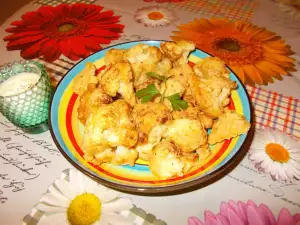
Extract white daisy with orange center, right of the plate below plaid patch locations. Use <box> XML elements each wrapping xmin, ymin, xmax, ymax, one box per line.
<box><xmin>249</xmin><ymin>128</ymin><xmax>300</xmax><ymax>184</ymax></box>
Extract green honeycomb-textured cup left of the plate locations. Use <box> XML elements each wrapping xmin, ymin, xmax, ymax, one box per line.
<box><xmin>0</xmin><ymin>61</ymin><xmax>53</xmax><ymax>133</ymax></box>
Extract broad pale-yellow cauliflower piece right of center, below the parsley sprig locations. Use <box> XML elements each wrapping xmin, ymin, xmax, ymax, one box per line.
<box><xmin>163</xmin><ymin>119</ymin><xmax>207</xmax><ymax>152</ymax></box>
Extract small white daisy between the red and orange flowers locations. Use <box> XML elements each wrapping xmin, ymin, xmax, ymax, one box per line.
<box><xmin>134</xmin><ymin>6</ymin><xmax>177</xmax><ymax>27</ymax></box>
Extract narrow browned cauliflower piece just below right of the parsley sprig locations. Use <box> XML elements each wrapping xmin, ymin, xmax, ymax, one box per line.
<box><xmin>172</xmin><ymin>106</ymin><xmax>213</xmax><ymax>129</ymax></box>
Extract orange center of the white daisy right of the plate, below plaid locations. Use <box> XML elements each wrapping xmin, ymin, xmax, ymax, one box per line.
<box><xmin>266</xmin><ymin>143</ymin><xmax>290</xmax><ymax>163</ymax></box>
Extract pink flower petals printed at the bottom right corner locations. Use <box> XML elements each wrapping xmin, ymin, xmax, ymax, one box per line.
<box><xmin>188</xmin><ymin>201</ymin><xmax>300</xmax><ymax>225</ymax></box>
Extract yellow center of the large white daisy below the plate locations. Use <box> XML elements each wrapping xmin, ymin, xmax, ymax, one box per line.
<box><xmin>67</xmin><ymin>193</ymin><xmax>101</xmax><ymax>225</ymax></box>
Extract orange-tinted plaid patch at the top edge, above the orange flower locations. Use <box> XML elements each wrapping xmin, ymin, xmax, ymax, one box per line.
<box><xmin>167</xmin><ymin>0</ymin><xmax>257</xmax><ymax>21</ymax></box>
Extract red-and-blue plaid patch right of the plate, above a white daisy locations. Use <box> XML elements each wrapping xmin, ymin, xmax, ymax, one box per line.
<box><xmin>246</xmin><ymin>86</ymin><xmax>300</xmax><ymax>138</ymax></box>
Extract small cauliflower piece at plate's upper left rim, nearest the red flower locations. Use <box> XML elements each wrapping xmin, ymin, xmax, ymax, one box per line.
<box><xmin>72</xmin><ymin>62</ymin><xmax>98</xmax><ymax>96</ymax></box>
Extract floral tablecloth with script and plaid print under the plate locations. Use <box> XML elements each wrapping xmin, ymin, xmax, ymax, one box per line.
<box><xmin>0</xmin><ymin>0</ymin><xmax>300</xmax><ymax>225</ymax></box>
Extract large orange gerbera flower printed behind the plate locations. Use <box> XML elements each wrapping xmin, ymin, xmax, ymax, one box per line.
<box><xmin>171</xmin><ymin>18</ymin><xmax>296</xmax><ymax>85</ymax></box>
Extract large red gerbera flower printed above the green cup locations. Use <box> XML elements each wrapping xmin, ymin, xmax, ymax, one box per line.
<box><xmin>4</xmin><ymin>4</ymin><xmax>124</xmax><ymax>62</ymax></box>
